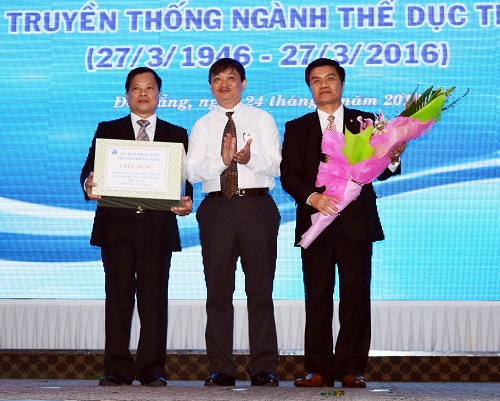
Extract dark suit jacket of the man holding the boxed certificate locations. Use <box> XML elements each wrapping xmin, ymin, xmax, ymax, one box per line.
<box><xmin>80</xmin><ymin>115</ymin><xmax>193</xmax><ymax>251</ymax></box>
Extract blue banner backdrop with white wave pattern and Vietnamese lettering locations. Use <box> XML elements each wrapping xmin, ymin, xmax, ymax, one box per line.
<box><xmin>0</xmin><ymin>0</ymin><xmax>500</xmax><ymax>300</ymax></box>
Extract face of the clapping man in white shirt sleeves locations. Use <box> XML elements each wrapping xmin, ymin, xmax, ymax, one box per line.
<box><xmin>210</xmin><ymin>70</ymin><xmax>247</xmax><ymax>109</ymax></box>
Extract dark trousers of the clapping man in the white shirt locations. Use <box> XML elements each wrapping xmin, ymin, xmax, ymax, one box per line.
<box><xmin>196</xmin><ymin>195</ymin><xmax>280</xmax><ymax>376</ymax></box>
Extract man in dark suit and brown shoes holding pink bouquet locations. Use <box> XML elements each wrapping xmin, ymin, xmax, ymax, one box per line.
<box><xmin>281</xmin><ymin>59</ymin><xmax>405</xmax><ymax>388</ymax></box>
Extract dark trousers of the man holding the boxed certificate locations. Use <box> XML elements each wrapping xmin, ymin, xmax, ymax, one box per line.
<box><xmin>101</xmin><ymin>213</ymin><xmax>172</xmax><ymax>383</ymax></box>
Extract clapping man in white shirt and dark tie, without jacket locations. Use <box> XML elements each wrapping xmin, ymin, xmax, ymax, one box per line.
<box><xmin>187</xmin><ymin>58</ymin><xmax>281</xmax><ymax>386</ymax></box>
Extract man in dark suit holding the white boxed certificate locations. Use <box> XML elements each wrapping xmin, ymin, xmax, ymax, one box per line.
<box><xmin>80</xmin><ymin>67</ymin><xmax>193</xmax><ymax>386</ymax></box>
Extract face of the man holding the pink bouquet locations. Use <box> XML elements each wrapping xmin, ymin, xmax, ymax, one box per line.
<box><xmin>309</xmin><ymin>65</ymin><xmax>344</xmax><ymax>112</ymax></box>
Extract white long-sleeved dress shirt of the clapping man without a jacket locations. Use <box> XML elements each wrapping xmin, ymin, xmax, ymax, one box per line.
<box><xmin>186</xmin><ymin>103</ymin><xmax>281</xmax><ymax>193</ymax></box>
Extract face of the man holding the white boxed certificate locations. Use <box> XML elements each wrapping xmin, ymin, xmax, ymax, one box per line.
<box><xmin>126</xmin><ymin>72</ymin><xmax>160</xmax><ymax>118</ymax></box>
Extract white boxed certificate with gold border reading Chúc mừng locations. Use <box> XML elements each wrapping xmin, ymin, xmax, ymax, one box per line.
<box><xmin>92</xmin><ymin>138</ymin><xmax>186</xmax><ymax>210</ymax></box>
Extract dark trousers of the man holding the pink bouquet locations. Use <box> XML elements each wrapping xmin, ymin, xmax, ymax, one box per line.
<box><xmin>302</xmin><ymin>217</ymin><xmax>373</xmax><ymax>381</ymax></box>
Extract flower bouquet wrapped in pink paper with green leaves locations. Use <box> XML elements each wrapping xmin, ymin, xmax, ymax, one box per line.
<box><xmin>299</xmin><ymin>87</ymin><xmax>466</xmax><ymax>248</ymax></box>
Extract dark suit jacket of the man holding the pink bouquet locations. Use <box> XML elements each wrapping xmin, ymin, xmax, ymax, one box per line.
<box><xmin>280</xmin><ymin>107</ymin><xmax>400</xmax><ymax>243</ymax></box>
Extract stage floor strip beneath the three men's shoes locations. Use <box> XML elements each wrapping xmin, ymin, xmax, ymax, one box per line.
<box><xmin>0</xmin><ymin>380</ymin><xmax>500</xmax><ymax>401</ymax></box>
